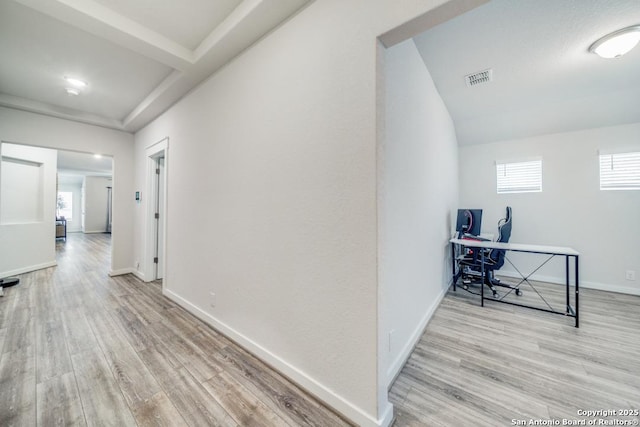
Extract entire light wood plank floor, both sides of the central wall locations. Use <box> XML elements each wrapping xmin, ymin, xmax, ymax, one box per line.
<box><xmin>0</xmin><ymin>234</ymin><xmax>640</xmax><ymax>427</ymax></box>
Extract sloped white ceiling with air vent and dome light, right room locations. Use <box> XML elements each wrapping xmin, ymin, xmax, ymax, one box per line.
<box><xmin>414</xmin><ymin>0</ymin><xmax>640</xmax><ymax>145</ymax></box>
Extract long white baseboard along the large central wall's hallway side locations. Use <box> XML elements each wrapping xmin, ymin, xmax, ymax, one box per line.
<box><xmin>163</xmin><ymin>289</ymin><xmax>393</xmax><ymax>427</ymax></box>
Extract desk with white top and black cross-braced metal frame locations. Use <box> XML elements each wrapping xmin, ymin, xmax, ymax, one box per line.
<box><xmin>449</xmin><ymin>239</ymin><xmax>580</xmax><ymax>328</ymax></box>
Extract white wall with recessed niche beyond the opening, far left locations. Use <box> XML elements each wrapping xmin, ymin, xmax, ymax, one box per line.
<box><xmin>0</xmin><ymin>143</ymin><xmax>57</xmax><ymax>278</ymax></box>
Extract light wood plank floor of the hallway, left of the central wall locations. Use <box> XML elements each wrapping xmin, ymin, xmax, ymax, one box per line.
<box><xmin>0</xmin><ymin>233</ymin><xmax>349</xmax><ymax>427</ymax></box>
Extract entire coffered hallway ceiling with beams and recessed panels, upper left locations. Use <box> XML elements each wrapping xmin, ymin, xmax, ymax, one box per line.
<box><xmin>0</xmin><ymin>0</ymin><xmax>311</xmax><ymax>132</ymax></box>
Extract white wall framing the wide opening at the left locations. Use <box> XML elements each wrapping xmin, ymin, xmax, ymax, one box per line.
<box><xmin>0</xmin><ymin>107</ymin><xmax>135</xmax><ymax>274</ymax></box>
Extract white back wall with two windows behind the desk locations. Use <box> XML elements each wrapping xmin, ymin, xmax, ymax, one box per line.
<box><xmin>460</xmin><ymin>124</ymin><xmax>640</xmax><ymax>294</ymax></box>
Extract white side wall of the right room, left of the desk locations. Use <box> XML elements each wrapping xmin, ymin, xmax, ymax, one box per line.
<box><xmin>379</xmin><ymin>39</ymin><xmax>458</xmax><ymax>386</ymax></box>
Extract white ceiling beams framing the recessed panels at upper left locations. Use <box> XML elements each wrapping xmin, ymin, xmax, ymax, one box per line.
<box><xmin>8</xmin><ymin>0</ymin><xmax>313</xmax><ymax>132</ymax></box>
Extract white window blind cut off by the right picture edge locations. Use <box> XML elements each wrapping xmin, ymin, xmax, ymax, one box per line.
<box><xmin>600</xmin><ymin>152</ymin><xmax>640</xmax><ymax>190</ymax></box>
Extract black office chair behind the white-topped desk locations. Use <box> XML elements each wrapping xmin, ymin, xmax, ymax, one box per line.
<box><xmin>460</xmin><ymin>206</ymin><xmax>522</xmax><ymax>297</ymax></box>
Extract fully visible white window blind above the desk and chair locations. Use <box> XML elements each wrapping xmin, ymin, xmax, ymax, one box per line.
<box><xmin>496</xmin><ymin>160</ymin><xmax>542</xmax><ymax>194</ymax></box>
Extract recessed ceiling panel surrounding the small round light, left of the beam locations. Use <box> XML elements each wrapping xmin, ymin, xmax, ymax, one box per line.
<box><xmin>0</xmin><ymin>1</ymin><xmax>172</xmax><ymax>119</ymax></box>
